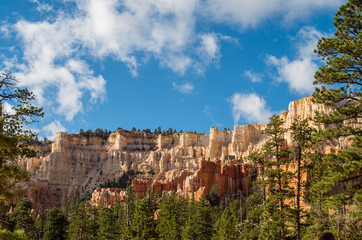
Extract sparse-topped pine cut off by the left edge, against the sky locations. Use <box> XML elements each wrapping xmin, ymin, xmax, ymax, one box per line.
<box><xmin>0</xmin><ymin>72</ymin><xmax>43</xmax><ymax>201</ymax></box>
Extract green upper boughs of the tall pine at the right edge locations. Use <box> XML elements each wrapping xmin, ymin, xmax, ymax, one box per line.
<box><xmin>313</xmin><ymin>0</ymin><xmax>362</xmax><ymax>138</ymax></box>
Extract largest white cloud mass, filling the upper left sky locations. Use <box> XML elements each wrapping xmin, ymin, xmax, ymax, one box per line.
<box><xmin>8</xmin><ymin>0</ymin><xmax>201</xmax><ymax>121</ymax></box>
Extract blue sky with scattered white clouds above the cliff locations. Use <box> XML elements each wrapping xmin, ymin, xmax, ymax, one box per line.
<box><xmin>0</xmin><ymin>0</ymin><xmax>346</xmax><ymax>137</ymax></box>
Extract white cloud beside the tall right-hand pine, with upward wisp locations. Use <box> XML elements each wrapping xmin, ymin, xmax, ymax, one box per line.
<box><xmin>267</xmin><ymin>27</ymin><xmax>322</xmax><ymax>94</ymax></box>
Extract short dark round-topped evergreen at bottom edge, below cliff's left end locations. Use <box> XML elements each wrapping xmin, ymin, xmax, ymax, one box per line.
<box><xmin>43</xmin><ymin>208</ymin><xmax>68</xmax><ymax>240</ymax></box>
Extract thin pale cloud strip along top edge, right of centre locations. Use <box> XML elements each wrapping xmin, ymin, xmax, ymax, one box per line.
<box><xmin>203</xmin><ymin>0</ymin><xmax>344</xmax><ymax>29</ymax></box>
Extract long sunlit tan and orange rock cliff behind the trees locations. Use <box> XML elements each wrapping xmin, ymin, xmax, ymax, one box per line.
<box><xmin>21</xmin><ymin>97</ymin><xmax>343</xmax><ymax>208</ymax></box>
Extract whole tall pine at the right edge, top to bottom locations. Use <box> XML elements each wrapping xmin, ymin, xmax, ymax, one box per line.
<box><xmin>308</xmin><ymin>0</ymin><xmax>362</xmax><ymax>237</ymax></box>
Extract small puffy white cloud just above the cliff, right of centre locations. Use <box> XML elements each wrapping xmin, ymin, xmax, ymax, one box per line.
<box><xmin>230</xmin><ymin>93</ymin><xmax>273</xmax><ymax>124</ymax></box>
